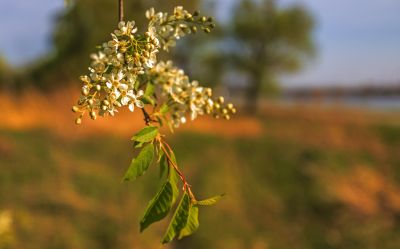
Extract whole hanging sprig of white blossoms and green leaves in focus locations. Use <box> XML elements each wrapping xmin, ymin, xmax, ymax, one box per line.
<box><xmin>72</xmin><ymin>6</ymin><xmax>236</xmax><ymax>243</ymax></box>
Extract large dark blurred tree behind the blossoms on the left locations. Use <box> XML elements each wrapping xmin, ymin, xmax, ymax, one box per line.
<box><xmin>30</xmin><ymin>0</ymin><xmax>199</xmax><ymax>88</ymax></box>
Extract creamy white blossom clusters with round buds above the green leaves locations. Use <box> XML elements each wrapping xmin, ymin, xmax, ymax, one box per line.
<box><xmin>72</xmin><ymin>6</ymin><xmax>236</xmax><ymax>126</ymax></box>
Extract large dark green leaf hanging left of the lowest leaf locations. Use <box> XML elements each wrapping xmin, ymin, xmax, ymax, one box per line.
<box><xmin>140</xmin><ymin>181</ymin><xmax>173</xmax><ymax>232</ymax></box>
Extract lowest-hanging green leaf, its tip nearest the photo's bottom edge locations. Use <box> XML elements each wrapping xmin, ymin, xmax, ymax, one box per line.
<box><xmin>161</xmin><ymin>192</ymin><xmax>191</xmax><ymax>244</ymax></box>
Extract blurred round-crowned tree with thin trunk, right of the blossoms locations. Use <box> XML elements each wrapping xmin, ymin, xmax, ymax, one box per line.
<box><xmin>229</xmin><ymin>0</ymin><xmax>314</xmax><ymax>111</ymax></box>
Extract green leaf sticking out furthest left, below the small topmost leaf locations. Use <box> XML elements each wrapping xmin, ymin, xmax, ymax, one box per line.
<box><xmin>123</xmin><ymin>143</ymin><xmax>154</xmax><ymax>181</ymax></box>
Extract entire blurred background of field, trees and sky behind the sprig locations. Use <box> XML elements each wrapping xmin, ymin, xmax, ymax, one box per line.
<box><xmin>0</xmin><ymin>0</ymin><xmax>400</xmax><ymax>249</ymax></box>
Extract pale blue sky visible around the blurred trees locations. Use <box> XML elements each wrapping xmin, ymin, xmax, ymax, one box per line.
<box><xmin>0</xmin><ymin>0</ymin><xmax>400</xmax><ymax>86</ymax></box>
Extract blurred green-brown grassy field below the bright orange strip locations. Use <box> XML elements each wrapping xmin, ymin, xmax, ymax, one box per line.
<box><xmin>0</xmin><ymin>110</ymin><xmax>400</xmax><ymax>249</ymax></box>
